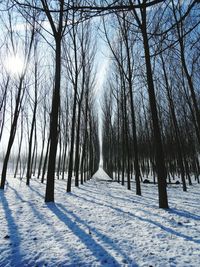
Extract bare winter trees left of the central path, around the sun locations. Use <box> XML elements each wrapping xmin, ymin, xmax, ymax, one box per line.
<box><xmin>0</xmin><ymin>1</ymin><xmax>99</xmax><ymax>202</ymax></box>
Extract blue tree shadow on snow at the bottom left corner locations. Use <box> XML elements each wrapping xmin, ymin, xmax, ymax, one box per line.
<box><xmin>0</xmin><ymin>190</ymin><xmax>23</xmax><ymax>266</ymax></box>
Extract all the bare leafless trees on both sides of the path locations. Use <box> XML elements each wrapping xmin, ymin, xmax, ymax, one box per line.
<box><xmin>0</xmin><ymin>0</ymin><xmax>200</xmax><ymax>208</ymax></box>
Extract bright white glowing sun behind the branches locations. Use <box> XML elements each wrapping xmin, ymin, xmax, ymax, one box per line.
<box><xmin>5</xmin><ymin>55</ymin><xmax>24</xmax><ymax>76</ymax></box>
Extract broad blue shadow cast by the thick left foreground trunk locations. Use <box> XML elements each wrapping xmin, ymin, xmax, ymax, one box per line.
<box><xmin>48</xmin><ymin>203</ymin><xmax>137</xmax><ymax>267</ymax></box>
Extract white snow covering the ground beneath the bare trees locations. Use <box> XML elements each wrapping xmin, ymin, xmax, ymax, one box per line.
<box><xmin>0</xmin><ymin>169</ymin><xmax>200</xmax><ymax>267</ymax></box>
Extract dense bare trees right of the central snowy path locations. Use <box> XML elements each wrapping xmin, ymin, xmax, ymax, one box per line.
<box><xmin>103</xmin><ymin>1</ymin><xmax>200</xmax><ymax>208</ymax></box>
